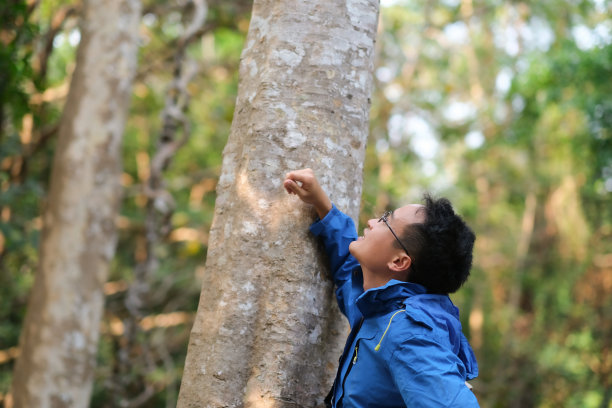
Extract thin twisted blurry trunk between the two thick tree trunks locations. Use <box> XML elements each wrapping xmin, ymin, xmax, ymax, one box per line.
<box><xmin>111</xmin><ymin>0</ymin><xmax>208</xmax><ymax>407</ymax></box>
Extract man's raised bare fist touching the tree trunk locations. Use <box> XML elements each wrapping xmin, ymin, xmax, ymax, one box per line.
<box><xmin>283</xmin><ymin>169</ymin><xmax>332</xmax><ymax>219</ymax></box>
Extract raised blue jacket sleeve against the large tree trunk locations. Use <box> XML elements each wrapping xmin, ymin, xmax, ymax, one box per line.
<box><xmin>310</xmin><ymin>205</ymin><xmax>363</xmax><ymax>327</ymax></box>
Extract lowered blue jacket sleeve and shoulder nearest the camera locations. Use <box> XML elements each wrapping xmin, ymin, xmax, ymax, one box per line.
<box><xmin>389</xmin><ymin>336</ymin><xmax>479</xmax><ymax>408</ymax></box>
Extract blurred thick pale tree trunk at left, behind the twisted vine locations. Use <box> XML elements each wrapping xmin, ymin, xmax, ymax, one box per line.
<box><xmin>12</xmin><ymin>0</ymin><xmax>140</xmax><ymax>408</ymax></box>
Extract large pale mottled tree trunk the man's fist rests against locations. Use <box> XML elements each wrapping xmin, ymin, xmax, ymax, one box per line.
<box><xmin>178</xmin><ymin>0</ymin><xmax>378</xmax><ymax>408</ymax></box>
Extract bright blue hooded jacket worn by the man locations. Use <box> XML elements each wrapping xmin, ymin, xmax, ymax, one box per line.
<box><xmin>310</xmin><ymin>206</ymin><xmax>478</xmax><ymax>408</ymax></box>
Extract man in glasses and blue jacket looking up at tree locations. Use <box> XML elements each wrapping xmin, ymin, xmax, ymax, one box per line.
<box><xmin>283</xmin><ymin>169</ymin><xmax>478</xmax><ymax>408</ymax></box>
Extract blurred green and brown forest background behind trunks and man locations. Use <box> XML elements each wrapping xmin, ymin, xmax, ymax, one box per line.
<box><xmin>0</xmin><ymin>0</ymin><xmax>612</xmax><ymax>408</ymax></box>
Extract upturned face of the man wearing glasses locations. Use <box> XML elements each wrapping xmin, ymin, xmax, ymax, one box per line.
<box><xmin>349</xmin><ymin>204</ymin><xmax>425</xmax><ymax>290</ymax></box>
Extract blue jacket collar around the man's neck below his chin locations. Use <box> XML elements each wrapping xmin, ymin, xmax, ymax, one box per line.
<box><xmin>357</xmin><ymin>279</ymin><xmax>427</xmax><ymax>317</ymax></box>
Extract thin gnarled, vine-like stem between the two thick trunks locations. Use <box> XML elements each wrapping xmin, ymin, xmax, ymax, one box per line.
<box><xmin>115</xmin><ymin>0</ymin><xmax>207</xmax><ymax>406</ymax></box>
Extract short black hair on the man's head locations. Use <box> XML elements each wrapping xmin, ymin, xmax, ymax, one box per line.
<box><xmin>400</xmin><ymin>194</ymin><xmax>476</xmax><ymax>294</ymax></box>
